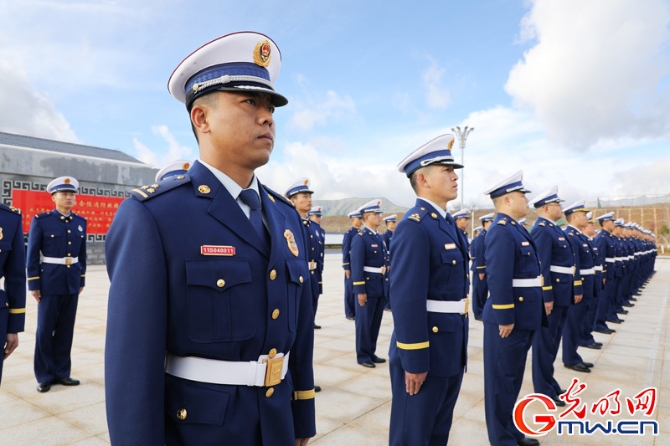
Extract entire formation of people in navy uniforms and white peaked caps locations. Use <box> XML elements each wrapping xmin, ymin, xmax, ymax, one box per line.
<box><xmin>0</xmin><ymin>32</ymin><xmax>656</xmax><ymax>446</ymax></box>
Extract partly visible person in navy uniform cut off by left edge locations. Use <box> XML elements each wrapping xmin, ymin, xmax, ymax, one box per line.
<box><xmin>0</xmin><ymin>203</ymin><xmax>26</xmax><ymax>383</ymax></box>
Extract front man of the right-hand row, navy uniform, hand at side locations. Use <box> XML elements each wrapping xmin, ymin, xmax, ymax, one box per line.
<box><xmin>389</xmin><ymin>135</ymin><xmax>469</xmax><ymax>445</ymax></box>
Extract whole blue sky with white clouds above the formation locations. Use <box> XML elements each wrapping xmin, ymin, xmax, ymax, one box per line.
<box><xmin>0</xmin><ymin>0</ymin><xmax>670</xmax><ymax>208</ymax></box>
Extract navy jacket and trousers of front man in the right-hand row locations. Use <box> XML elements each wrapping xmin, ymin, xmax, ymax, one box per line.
<box><xmin>389</xmin><ymin>199</ymin><xmax>469</xmax><ymax>446</ymax></box>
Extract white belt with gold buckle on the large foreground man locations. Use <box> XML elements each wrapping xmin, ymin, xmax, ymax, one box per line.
<box><xmin>165</xmin><ymin>352</ymin><xmax>290</xmax><ymax>387</ymax></box>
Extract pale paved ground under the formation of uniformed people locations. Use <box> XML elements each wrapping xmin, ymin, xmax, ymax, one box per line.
<box><xmin>0</xmin><ymin>254</ymin><xmax>670</xmax><ymax>446</ymax></box>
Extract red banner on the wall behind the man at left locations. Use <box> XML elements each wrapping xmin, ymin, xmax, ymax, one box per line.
<box><xmin>12</xmin><ymin>189</ymin><xmax>123</xmax><ymax>234</ymax></box>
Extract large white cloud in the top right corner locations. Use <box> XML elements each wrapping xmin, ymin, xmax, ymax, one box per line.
<box><xmin>505</xmin><ymin>0</ymin><xmax>670</xmax><ymax>149</ymax></box>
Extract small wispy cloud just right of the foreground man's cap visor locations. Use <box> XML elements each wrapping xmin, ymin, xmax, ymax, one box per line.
<box><xmin>290</xmin><ymin>91</ymin><xmax>356</xmax><ymax>132</ymax></box>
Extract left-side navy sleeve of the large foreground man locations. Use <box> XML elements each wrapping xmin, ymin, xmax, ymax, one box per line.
<box><xmin>105</xmin><ymin>199</ymin><xmax>168</xmax><ymax>446</ymax></box>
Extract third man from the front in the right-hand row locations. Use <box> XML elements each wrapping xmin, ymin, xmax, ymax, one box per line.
<box><xmin>530</xmin><ymin>186</ymin><xmax>581</xmax><ymax>406</ymax></box>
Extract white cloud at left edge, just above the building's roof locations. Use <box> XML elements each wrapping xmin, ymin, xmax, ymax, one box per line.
<box><xmin>0</xmin><ymin>61</ymin><xmax>77</xmax><ymax>142</ymax></box>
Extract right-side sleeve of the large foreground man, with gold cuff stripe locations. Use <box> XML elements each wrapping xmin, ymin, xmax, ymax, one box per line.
<box><xmin>289</xmin><ymin>222</ymin><xmax>316</xmax><ymax>438</ymax></box>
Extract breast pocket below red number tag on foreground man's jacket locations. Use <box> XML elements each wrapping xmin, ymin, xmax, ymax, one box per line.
<box><xmin>186</xmin><ymin>259</ymin><xmax>258</xmax><ymax>342</ymax></box>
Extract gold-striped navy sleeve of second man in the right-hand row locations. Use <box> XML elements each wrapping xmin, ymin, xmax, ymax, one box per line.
<box><xmin>484</xmin><ymin>228</ymin><xmax>516</xmax><ymax>325</ymax></box>
